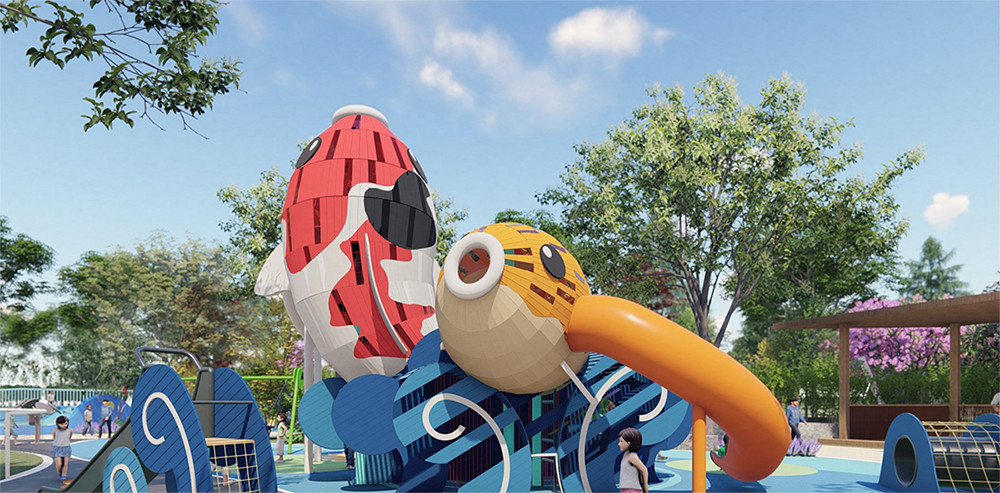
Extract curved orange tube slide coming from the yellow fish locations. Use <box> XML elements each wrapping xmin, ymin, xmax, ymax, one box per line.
<box><xmin>564</xmin><ymin>295</ymin><xmax>791</xmax><ymax>481</ymax></box>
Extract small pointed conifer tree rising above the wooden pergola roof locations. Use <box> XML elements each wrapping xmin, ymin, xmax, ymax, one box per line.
<box><xmin>899</xmin><ymin>236</ymin><xmax>968</xmax><ymax>300</ymax></box>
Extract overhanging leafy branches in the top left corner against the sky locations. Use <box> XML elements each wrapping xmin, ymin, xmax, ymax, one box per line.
<box><xmin>0</xmin><ymin>0</ymin><xmax>241</xmax><ymax>130</ymax></box>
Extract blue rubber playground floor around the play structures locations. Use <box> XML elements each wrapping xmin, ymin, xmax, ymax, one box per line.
<box><xmin>3</xmin><ymin>439</ymin><xmax>888</xmax><ymax>493</ymax></box>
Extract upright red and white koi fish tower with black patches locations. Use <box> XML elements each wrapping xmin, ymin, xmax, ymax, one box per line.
<box><xmin>254</xmin><ymin>105</ymin><xmax>437</xmax><ymax>380</ymax></box>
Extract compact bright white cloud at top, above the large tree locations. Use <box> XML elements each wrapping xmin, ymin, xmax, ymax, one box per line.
<box><xmin>549</xmin><ymin>7</ymin><xmax>670</xmax><ymax>62</ymax></box>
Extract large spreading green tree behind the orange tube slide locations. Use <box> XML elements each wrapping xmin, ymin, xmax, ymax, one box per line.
<box><xmin>539</xmin><ymin>74</ymin><xmax>923</xmax><ymax>345</ymax></box>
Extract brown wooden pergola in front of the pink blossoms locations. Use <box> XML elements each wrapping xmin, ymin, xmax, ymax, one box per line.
<box><xmin>773</xmin><ymin>292</ymin><xmax>1000</xmax><ymax>438</ymax></box>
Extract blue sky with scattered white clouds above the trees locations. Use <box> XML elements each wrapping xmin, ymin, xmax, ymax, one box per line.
<box><xmin>0</xmin><ymin>0</ymin><xmax>1000</xmax><ymax>346</ymax></box>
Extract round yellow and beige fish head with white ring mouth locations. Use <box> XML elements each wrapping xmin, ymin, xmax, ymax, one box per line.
<box><xmin>437</xmin><ymin>223</ymin><xmax>590</xmax><ymax>394</ymax></box>
